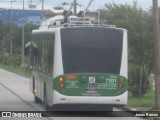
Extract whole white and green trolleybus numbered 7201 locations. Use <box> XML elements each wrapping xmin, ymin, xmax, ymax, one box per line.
<box><xmin>30</xmin><ymin>15</ymin><xmax>128</xmax><ymax>111</ymax></box>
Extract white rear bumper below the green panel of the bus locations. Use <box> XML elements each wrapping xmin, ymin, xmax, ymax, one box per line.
<box><xmin>53</xmin><ymin>90</ymin><xmax>128</xmax><ymax>106</ymax></box>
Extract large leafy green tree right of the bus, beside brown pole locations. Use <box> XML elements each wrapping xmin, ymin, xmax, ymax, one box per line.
<box><xmin>101</xmin><ymin>2</ymin><xmax>153</xmax><ymax>97</ymax></box>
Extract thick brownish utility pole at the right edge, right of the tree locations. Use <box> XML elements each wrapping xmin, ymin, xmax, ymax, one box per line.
<box><xmin>153</xmin><ymin>0</ymin><xmax>160</xmax><ymax>109</ymax></box>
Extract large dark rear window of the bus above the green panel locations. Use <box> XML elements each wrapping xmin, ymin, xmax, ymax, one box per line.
<box><xmin>61</xmin><ymin>27</ymin><xmax>123</xmax><ymax>74</ymax></box>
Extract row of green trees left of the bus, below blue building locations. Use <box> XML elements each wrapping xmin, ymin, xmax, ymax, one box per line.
<box><xmin>0</xmin><ymin>21</ymin><xmax>39</xmax><ymax>67</ymax></box>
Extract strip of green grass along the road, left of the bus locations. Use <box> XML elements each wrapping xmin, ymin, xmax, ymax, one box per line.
<box><xmin>0</xmin><ymin>64</ymin><xmax>30</xmax><ymax>77</ymax></box>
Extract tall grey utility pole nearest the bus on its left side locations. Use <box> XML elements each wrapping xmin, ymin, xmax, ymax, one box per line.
<box><xmin>21</xmin><ymin>0</ymin><xmax>24</xmax><ymax>66</ymax></box>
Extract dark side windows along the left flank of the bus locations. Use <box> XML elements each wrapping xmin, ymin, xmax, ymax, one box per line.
<box><xmin>31</xmin><ymin>34</ymin><xmax>54</xmax><ymax>77</ymax></box>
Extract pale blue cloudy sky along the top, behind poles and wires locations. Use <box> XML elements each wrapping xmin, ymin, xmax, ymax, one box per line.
<box><xmin>0</xmin><ymin>0</ymin><xmax>160</xmax><ymax>10</ymax></box>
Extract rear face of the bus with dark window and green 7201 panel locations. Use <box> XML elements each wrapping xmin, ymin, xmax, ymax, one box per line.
<box><xmin>53</xmin><ymin>27</ymin><xmax>128</xmax><ymax>111</ymax></box>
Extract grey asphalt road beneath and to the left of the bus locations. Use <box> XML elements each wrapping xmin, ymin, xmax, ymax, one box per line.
<box><xmin>0</xmin><ymin>69</ymin><xmax>147</xmax><ymax>120</ymax></box>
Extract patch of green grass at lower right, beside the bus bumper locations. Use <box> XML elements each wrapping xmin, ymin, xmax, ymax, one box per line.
<box><xmin>127</xmin><ymin>90</ymin><xmax>155</xmax><ymax>108</ymax></box>
